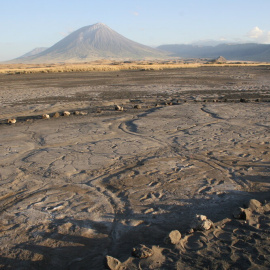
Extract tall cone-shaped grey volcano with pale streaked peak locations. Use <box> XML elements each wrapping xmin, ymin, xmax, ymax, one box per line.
<box><xmin>11</xmin><ymin>23</ymin><xmax>166</xmax><ymax>63</ymax></box>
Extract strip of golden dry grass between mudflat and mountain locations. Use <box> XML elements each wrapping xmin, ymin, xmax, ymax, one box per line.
<box><xmin>0</xmin><ymin>61</ymin><xmax>270</xmax><ymax>74</ymax></box>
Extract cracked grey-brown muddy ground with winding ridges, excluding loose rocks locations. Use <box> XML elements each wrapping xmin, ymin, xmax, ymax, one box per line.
<box><xmin>0</xmin><ymin>66</ymin><xmax>270</xmax><ymax>269</ymax></box>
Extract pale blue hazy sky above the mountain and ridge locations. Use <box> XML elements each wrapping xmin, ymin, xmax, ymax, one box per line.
<box><xmin>0</xmin><ymin>0</ymin><xmax>270</xmax><ymax>61</ymax></box>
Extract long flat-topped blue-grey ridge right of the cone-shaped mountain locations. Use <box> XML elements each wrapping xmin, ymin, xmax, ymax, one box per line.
<box><xmin>158</xmin><ymin>43</ymin><xmax>270</xmax><ymax>62</ymax></box>
